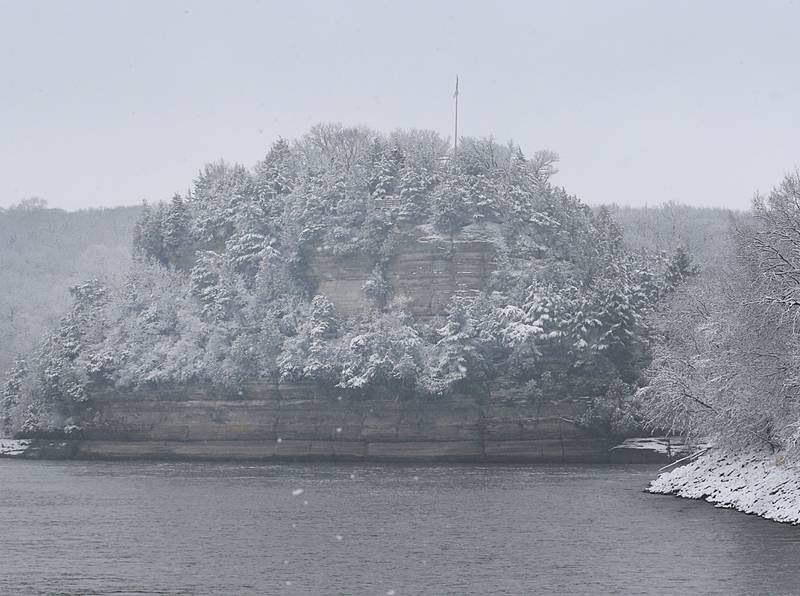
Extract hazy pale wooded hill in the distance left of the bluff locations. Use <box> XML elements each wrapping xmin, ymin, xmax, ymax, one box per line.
<box><xmin>0</xmin><ymin>201</ymin><xmax>141</xmax><ymax>371</ymax></box>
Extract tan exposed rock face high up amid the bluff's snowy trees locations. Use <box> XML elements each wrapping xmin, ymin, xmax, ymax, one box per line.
<box><xmin>309</xmin><ymin>224</ymin><xmax>499</xmax><ymax>320</ymax></box>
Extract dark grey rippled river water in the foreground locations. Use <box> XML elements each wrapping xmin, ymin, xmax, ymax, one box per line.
<box><xmin>0</xmin><ymin>460</ymin><xmax>800</xmax><ymax>596</ymax></box>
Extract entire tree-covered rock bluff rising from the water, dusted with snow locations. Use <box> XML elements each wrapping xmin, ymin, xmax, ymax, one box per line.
<box><xmin>2</xmin><ymin>125</ymin><xmax>696</xmax><ymax>461</ymax></box>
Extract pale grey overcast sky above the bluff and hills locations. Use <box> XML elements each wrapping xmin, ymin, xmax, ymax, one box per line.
<box><xmin>0</xmin><ymin>0</ymin><xmax>800</xmax><ymax>209</ymax></box>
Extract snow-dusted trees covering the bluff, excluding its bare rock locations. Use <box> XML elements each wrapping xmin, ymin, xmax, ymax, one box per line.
<box><xmin>2</xmin><ymin>124</ymin><xmax>708</xmax><ymax>436</ymax></box>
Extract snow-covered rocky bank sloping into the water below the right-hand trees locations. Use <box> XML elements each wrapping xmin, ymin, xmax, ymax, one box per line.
<box><xmin>648</xmin><ymin>449</ymin><xmax>800</xmax><ymax>524</ymax></box>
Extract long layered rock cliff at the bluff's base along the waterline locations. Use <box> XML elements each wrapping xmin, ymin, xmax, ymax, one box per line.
<box><xmin>65</xmin><ymin>383</ymin><xmax>610</xmax><ymax>462</ymax></box>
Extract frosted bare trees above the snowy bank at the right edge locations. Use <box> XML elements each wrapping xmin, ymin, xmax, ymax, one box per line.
<box><xmin>645</xmin><ymin>174</ymin><xmax>800</xmax><ymax>457</ymax></box>
